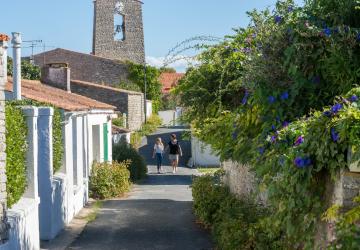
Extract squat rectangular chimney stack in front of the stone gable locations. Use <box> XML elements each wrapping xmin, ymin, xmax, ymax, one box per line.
<box><xmin>41</xmin><ymin>63</ymin><xmax>71</xmax><ymax>93</ymax></box>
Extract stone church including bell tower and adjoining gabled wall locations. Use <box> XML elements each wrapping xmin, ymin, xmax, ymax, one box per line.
<box><xmin>34</xmin><ymin>0</ymin><xmax>145</xmax><ymax>86</ymax></box>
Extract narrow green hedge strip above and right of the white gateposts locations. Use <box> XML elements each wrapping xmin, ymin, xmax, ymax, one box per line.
<box><xmin>9</xmin><ymin>100</ymin><xmax>64</xmax><ymax>172</ymax></box>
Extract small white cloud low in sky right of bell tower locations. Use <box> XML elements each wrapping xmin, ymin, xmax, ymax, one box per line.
<box><xmin>146</xmin><ymin>55</ymin><xmax>197</xmax><ymax>72</ymax></box>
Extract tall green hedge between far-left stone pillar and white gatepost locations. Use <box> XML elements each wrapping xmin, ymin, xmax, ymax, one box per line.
<box><xmin>5</xmin><ymin>102</ymin><xmax>28</xmax><ymax>207</ymax></box>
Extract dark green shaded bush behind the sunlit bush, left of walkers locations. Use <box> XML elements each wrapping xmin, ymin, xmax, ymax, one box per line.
<box><xmin>113</xmin><ymin>140</ymin><xmax>147</xmax><ymax>181</ymax></box>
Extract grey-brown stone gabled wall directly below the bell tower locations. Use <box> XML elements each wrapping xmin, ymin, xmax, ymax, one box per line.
<box><xmin>34</xmin><ymin>49</ymin><xmax>128</xmax><ymax>86</ymax></box>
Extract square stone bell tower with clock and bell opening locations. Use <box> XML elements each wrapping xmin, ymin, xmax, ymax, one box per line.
<box><xmin>93</xmin><ymin>0</ymin><xmax>145</xmax><ymax>64</ymax></box>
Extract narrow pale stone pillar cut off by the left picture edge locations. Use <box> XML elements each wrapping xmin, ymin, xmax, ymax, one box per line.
<box><xmin>0</xmin><ymin>41</ymin><xmax>8</xmax><ymax>245</ymax></box>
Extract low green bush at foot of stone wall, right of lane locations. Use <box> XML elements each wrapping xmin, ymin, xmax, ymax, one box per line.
<box><xmin>192</xmin><ymin>175</ymin><xmax>286</xmax><ymax>250</ymax></box>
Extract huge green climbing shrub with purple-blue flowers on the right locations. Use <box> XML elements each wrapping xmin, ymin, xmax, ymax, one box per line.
<box><xmin>176</xmin><ymin>0</ymin><xmax>360</xmax><ymax>246</ymax></box>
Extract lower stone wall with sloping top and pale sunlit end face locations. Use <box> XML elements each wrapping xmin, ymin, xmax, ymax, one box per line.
<box><xmin>71</xmin><ymin>81</ymin><xmax>145</xmax><ymax>130</ymax></box>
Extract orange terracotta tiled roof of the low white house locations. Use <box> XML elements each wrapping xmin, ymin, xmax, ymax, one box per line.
<box><xmin>5</xmin><ymin>78</ymin><xmax>115</xmax><ymax>111</ymax></box>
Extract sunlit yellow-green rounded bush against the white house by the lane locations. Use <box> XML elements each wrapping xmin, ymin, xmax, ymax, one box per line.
<box><xmin>90</xmin><ymin>161</ymin><xmax>130</xmax><ymax>199</ymax></box>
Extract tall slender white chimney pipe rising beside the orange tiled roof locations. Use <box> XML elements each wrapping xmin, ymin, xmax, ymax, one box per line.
<box><xmin>11</xmin><ymin>32</ymin><xmax>22</xmax><ymax>100</ymax></box>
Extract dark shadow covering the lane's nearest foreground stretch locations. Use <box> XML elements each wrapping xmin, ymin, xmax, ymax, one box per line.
<box><xmin>68</xmin><ymin>199</ymin><xmax>213</xmax><ymax>250</ymax></box>
